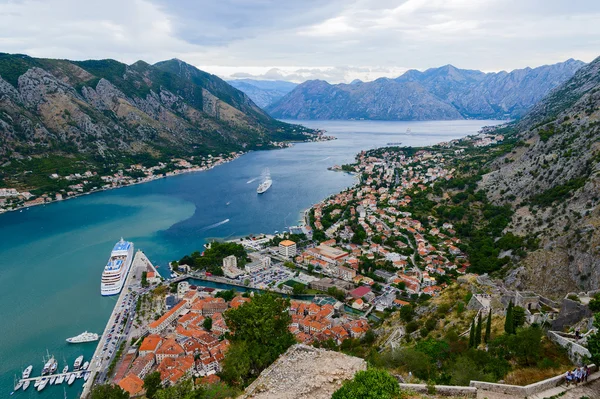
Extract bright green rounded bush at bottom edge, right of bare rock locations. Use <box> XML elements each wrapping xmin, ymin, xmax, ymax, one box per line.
<box><xmin>331</xmin><ymin>369</ymin><xmax>401</xmax><ymax>399</ymax></box>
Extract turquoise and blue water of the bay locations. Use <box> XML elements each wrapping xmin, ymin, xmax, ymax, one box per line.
<box><xmin>0</xmin><ymin>121</ymin><xmax>504</xmax><ymax>398</ymax></box>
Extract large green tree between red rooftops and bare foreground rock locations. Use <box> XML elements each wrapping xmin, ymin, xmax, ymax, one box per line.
<box><xmin>223</xmin><ymin>293</ymin><xmax>296</xmax><ymax>384</ymax></box>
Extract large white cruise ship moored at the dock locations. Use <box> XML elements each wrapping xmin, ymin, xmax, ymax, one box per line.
<box><xmin>100</xmin><ymin>238</ymin><xmax>133</xmax><ymax>296</ymax></box>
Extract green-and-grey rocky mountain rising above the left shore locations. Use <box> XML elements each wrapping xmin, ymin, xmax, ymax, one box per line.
<box><xmin>0</xmin><ymin>54</ymin><xmax>308</xmax><ymax>164</ymax></box>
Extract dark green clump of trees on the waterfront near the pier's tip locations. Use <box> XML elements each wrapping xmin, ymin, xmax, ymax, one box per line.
<box><xmin>179</xmin><ymin>242</ymin><xmax>248</xmax><ymax>276</ymax></box>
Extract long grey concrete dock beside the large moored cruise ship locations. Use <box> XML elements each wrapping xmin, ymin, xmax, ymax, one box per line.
<box><xmin>81</xmin><ymin>250</ymin><xmax>150</xmax><ymax>399</ymax></box>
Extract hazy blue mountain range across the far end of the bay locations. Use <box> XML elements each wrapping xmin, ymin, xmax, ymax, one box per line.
<box><xmin>267</xmin><ymin>59</ymin><xmax>584</xmax><ymax>120</ymax></box>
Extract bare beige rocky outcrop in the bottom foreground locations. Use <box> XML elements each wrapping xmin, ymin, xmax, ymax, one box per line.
<box><xmin>241</xmin><ymin>344</ymin><xmax>367</xmax><ymax>399</ymax></box>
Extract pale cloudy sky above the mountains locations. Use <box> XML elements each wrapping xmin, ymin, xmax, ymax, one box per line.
<box><xmin>0</xmin><ymin>0</ymin><xmax>600</xmax><ymax>83</ymax></box>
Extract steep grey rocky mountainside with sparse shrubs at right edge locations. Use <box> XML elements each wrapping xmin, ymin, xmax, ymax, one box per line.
<box><xmin>480</xmin><ymin>58</ymin><xmax>600</xmax><ymax>296</ymax></box>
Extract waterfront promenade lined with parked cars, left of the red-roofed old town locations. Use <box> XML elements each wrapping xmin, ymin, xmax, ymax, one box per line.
<box><xmin>81</xmin><ymin>250</ymin><xmax>150</xmax><ymax>399</ymax></box>
